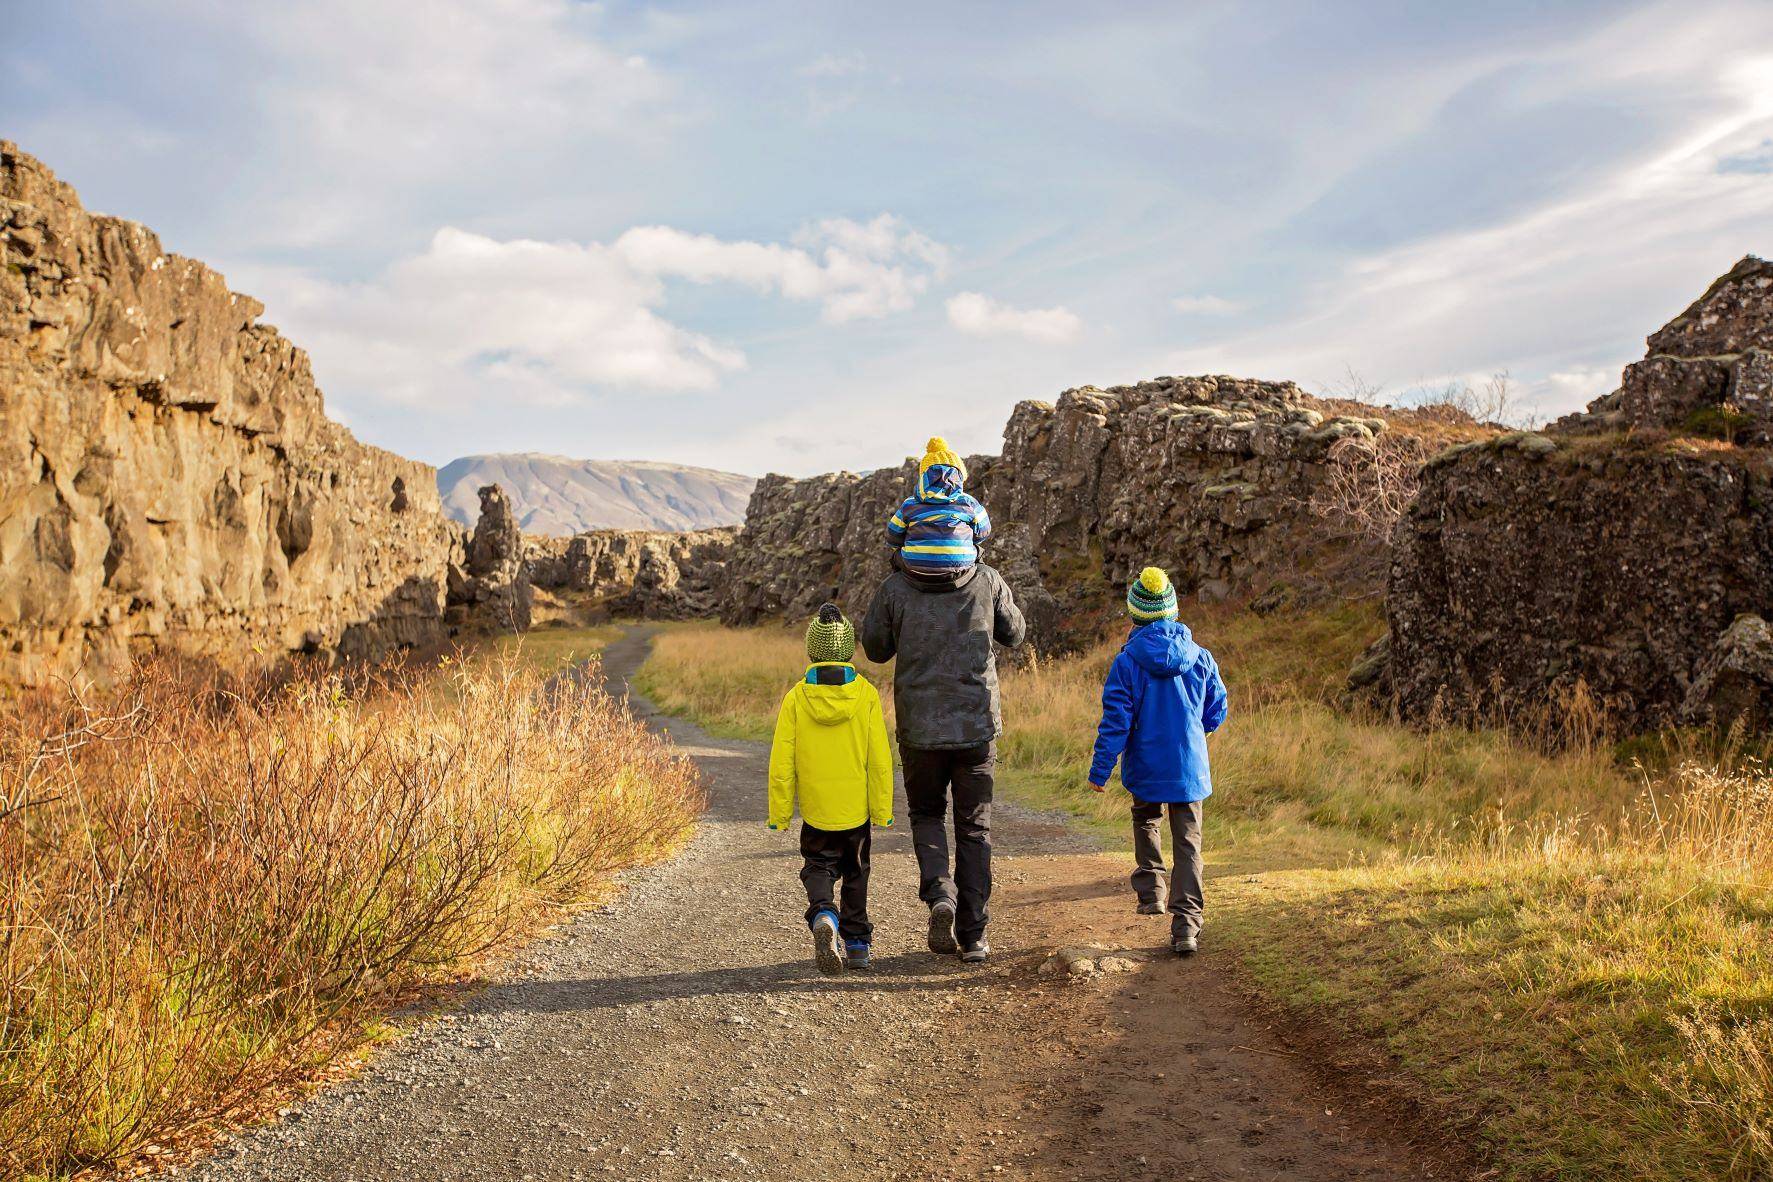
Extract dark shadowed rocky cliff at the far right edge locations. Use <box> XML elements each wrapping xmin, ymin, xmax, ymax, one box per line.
<box><xmin>1365</xmin><ymin>259</ymin><xmax>1773</xmax><ymax>728</ymax></box>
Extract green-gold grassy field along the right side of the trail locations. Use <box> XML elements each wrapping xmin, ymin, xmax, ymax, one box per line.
<box><xmin>642</xmin><ymin>604</ymin><xmax>1773</xmax><ymax>1182</ymax></box>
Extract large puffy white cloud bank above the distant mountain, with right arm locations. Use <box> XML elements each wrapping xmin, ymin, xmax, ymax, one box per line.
<box><xmin>234</xmin><ymin>214</ymin><xmax>941</xmax><ymax>404</ymax></box>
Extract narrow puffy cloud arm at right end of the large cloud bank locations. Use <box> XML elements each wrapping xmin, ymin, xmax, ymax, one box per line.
<box><xmin>615</xmin><ymin>214</ymin><xmax>949</xmax><ymax>324</ymax></box>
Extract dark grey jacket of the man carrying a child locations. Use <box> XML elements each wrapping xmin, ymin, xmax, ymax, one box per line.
<box><xmin>862</xmin><ymin>564</ymin><xmax>1028</xmax><ymax>750</ymax></box>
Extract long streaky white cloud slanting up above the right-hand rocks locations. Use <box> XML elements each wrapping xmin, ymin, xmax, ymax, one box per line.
<box><xmin>1163</xmin><ymin>41</ymin><xmax>1773</xmax><ymax>415</ymax></box>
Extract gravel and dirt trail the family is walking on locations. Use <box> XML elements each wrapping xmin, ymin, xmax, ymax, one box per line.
<box><xmin>188</xmin><ymin>631</ymin><xmax>1450</xmax><ymax>1182</ymax></box>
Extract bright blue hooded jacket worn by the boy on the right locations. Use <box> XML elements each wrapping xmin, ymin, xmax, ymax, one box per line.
<box><xmin>1090</xmin><ymin>620</ymin><xmax>1225</xmax><ymax>805</ymax></box>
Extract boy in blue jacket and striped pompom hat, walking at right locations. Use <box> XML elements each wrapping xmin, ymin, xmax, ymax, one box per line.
<box><xmin>1090</xmin><ymin>567</ymin><xmax>1225</xmax><ymax>957</ymax></box>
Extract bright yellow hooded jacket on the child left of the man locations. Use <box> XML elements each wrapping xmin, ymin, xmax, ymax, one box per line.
<box><xmin>769</xmin><ymin>665</ymin><xmax>892</xmax><ymax>829</ymax></box>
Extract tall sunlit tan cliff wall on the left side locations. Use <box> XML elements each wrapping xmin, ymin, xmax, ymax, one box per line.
<box><xmin>0</xmin><ymin>144</ymin><xmax>459</xmax><ymax>682</ymax></box>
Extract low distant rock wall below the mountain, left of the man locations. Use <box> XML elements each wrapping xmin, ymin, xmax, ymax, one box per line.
<box><xmin>523</xmin><ymin>526</ymin><xmax>739</xmax><ymax>620</ymax></box>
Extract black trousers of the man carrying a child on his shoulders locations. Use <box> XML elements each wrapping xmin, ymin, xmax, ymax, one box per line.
<box><xmin>899</xmin><ymin>743</ymin><xmax>996</xmax><ymax>948</ymax></box>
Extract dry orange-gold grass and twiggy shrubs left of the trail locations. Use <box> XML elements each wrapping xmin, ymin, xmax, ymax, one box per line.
<box><xmin>0</xmin><ymin>659</ymin><xmax>700</xmax><ymax>1178</ymax></box>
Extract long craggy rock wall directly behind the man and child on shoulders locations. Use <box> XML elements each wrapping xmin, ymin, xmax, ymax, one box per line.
<box><xmin>722</xmin><ymin>376</ymin><xmax>1477</xmax><ymax>647</ymax></box>
